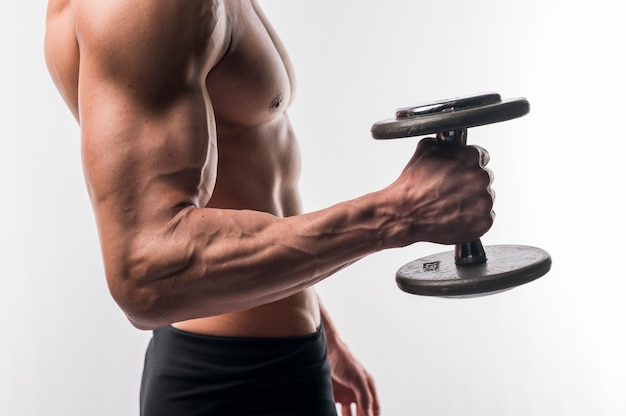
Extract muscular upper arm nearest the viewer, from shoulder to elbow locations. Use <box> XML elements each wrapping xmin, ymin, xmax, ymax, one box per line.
<box><xmin>77</xmin><ymin>0</ymin><xmax>227</xmax><ymax>286</ymax></box>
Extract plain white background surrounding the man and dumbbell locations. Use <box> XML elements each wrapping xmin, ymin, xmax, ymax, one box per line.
<box><xmin>0</xmin><ymin>0</ymin><xmax>626</xmax><ymax>416</ymax></box>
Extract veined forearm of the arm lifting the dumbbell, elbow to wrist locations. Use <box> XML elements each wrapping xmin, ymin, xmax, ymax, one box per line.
<box><xmin>113</xmin><ymin>188</ymin><xmax>397</xmax><ymax>327</ymax></box>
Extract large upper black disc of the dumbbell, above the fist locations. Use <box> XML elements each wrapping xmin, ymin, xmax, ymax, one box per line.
<box><xmin>371</xmin><ymin>98</ymin><xmax>530</xmax><ymax>140</ymax></box>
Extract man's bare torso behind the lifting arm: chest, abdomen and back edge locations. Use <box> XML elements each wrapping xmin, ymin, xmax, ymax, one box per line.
<box><xmin>46</xmin><ymin>0</ymin><xmax>320</xmax><ymax>336</ymax></box>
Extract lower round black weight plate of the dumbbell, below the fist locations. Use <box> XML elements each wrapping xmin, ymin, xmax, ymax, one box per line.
<box><xmin>396</xmin><ymin>245</ymin><xmax>552</xmax><ymax>297</ymax></box>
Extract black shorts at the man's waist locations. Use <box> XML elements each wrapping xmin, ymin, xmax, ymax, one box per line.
<box><xmin>140</xmin><ymin>326</ymin><xmax>337</xmax><ymax>416</ymax></box>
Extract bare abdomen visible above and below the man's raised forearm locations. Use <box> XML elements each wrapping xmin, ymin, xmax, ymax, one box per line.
<box><xmin>173</xmin><ymin>113</ymin><xmax>321</xmax><ymax>337</ymax></box>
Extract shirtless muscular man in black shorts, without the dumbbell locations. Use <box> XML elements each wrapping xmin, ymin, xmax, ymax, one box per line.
<box><xmin>45</xmin><ymin>0</ymin><xmax>493</xmax><ymax>416</ymax></box>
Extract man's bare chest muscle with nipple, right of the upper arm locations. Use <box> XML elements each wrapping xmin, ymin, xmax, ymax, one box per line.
<box><xmin>206</xmin><ymin>2</ymin><xmax>293</xmax><ymax>125</ymax></box>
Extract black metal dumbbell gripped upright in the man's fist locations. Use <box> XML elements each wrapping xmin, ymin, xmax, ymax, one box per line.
<box><xmin>372</xmin><ymin>94</ymin><xmax>552</xmax><ymax>297</ymax></box>
